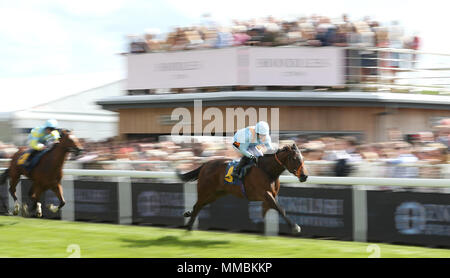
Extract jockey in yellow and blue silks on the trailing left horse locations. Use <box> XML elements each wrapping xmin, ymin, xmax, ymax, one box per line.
<box><xmin>24</xmin><ymin>119</ymin><xmax>60</xmax><ymax>167</ymax></box>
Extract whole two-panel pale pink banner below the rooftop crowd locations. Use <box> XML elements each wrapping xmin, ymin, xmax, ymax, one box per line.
<box><xmin>127</xmin><ymin>47</ymin><xmax>345</xmax><ymax>90</ymax></box>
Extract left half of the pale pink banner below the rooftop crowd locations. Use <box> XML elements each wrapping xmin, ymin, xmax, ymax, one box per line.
<box><xmin>128</xmin><ymin>48</ymin><xmax>237</xmax><ymax>90</ymax></box>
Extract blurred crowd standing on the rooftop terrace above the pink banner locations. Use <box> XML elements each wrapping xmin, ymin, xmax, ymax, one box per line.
<box><xmin>128</xmin><ymin>14</ymin><xmax>420</xmax><ymax>53</ymax></box>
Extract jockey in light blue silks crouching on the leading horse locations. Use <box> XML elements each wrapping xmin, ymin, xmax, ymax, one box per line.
<box><xmin>233</xmin><ymin>121</ymin><xmax>274</xmax><ymax>179</ymax></box>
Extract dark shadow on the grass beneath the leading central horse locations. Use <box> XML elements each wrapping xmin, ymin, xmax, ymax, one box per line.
<box><xmin>120</xmin><ymin>236</ymin><xmax>230</xmax><ymax>247</ymax></box>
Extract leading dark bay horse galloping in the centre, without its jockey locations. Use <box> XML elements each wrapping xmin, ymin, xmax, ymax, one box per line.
<box><xmin>178</xmin><ymin>144</ymin><xmax>308</xmax><ymax>234</ymax></box>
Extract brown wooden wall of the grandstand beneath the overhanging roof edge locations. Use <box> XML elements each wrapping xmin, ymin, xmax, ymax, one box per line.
<box><xmin>119</xmin><ymin>106</ymin><xmax>450</xmax><ymax>142</ymax></box>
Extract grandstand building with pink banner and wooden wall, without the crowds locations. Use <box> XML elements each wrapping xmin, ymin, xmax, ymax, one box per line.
<box><xmin>97</xmin><ymin>47</ymin><xmax>450</xmax><ymax>142</ymax></box>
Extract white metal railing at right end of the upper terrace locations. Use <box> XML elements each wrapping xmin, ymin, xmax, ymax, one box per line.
<box><xmin>345</xmin><ymin>47</ymin><xmax>450</xmax><ymax>95</ymax></box>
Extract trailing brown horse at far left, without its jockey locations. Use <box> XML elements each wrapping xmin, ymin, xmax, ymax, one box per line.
<box><xmin>0</xmin><ymin>129</ymin><xmax>82</xmax><ymax>217</ymax></box>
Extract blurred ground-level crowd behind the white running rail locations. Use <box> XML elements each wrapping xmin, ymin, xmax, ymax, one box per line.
<box><xmin>0</xmin><ymin>118</ymin><xmax>450</xmax><ymax>178</ymax></box>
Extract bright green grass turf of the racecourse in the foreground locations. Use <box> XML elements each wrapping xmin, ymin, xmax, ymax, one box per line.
<box><xmin>0</xmin><ymin>216</ymin><xmax>450</xmax><ymax>258</ymax></box>
